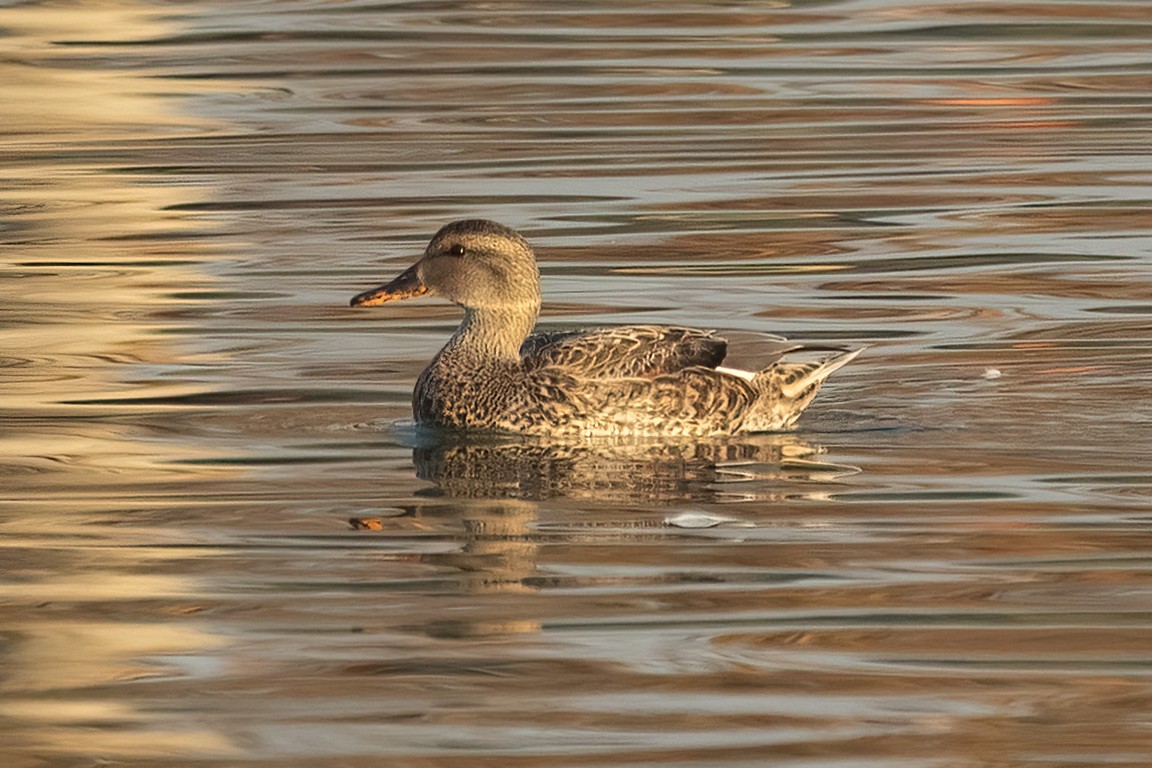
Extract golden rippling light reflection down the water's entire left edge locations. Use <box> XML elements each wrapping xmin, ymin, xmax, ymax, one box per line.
<box><xmin>0</xmin><ymin>2</ymin><xmax>238</xmax><ymax>765</ymax></box>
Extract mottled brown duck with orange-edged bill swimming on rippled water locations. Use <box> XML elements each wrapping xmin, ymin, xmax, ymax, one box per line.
<box><xmin>350</xmin><ymin>219</ymin><xmax>863</xmax><ymax>439</ymax></box>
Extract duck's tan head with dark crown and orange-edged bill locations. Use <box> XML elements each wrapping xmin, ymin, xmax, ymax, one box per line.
<box><xmin>351</xmin><ymin>219</ymin><xmax>540</xmax><ymax>312</ymax></box>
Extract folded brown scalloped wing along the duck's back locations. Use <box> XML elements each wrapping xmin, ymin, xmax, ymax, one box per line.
<box><xmin>520</xmin><ymin>326</ymin><xmax>728</xmax><ymax>379</ymax></box>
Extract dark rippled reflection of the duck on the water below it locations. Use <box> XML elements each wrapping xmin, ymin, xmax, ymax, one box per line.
<box><xmin>354</xmin><ymin>433</ymin><xmax>857</xmax><ymax>637</ymax></box>
